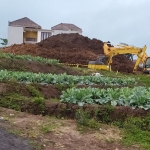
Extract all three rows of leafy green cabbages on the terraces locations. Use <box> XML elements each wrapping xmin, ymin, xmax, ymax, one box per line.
<box><xmin>0</xmin><ymin>53</ymin><xmax>150</xmax><ymax>110</ymax></box>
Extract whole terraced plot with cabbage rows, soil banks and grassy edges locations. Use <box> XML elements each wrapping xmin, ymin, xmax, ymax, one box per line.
<box><xmin>0</xmin><ymin>53</ymin><xmax>150</xmax><ymax>149</ymax></box>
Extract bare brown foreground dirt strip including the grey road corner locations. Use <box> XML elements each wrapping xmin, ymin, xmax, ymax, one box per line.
<box><xmin>0</xmin><ymin>108</ymin><xmax>138</xmax><ymax>150</ymax></box>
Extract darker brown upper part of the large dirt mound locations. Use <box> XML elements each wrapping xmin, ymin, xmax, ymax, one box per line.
<box><xmin>38</xmin><ymin>34</ymin><xmax>103</xmax><ymax>54</ymax></box>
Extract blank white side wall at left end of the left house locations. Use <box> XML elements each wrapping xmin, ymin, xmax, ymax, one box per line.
<box><xmin>8</xmin><ymin>26</ymin><xmax>23</xmax><ymax>46</ymax></box>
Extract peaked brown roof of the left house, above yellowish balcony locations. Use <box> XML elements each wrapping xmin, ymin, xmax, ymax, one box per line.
<box><xmin>9</xmin><ymin>17</ymin><xmax>42</xmax><ymax>29</ymax></box>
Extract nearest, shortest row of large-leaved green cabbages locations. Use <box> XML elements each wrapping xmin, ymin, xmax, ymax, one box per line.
<box><xmin>61</xmin><ymin>87</ymin><xmax>150</xmax><ymax>110</ymax></box>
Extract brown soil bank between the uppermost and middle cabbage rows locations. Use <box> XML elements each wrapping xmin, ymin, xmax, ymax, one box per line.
<box><xmin>0</xmin><ymin>58</ymin><xmax>82</xmax><ymax>75</ymax></box>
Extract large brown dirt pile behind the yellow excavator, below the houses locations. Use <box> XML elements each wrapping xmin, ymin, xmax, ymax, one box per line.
<box><xmin>2</xmin><ymin>34</ymin><xmax>134</xmax><ymax>72</ymax></box>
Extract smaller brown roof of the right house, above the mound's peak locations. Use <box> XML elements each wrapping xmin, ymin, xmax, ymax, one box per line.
<box><xmin>51</xmin><ymin>23</ymin><xmax>82</xmax><ymax>32</ymax></box>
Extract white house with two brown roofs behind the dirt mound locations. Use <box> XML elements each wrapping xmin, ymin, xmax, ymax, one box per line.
<box><xmin>8</xmin><ymin>17</ymin><xmax>82</xmax><ymax>46</ymax></box>
